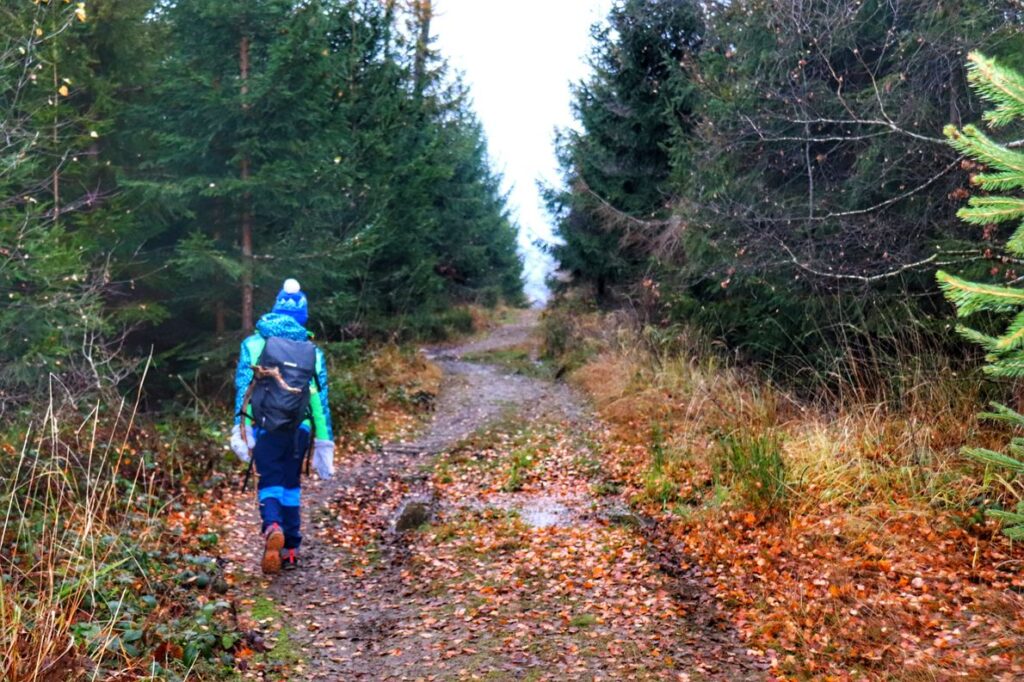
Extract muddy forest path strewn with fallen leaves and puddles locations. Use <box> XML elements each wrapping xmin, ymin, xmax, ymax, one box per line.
<box><xmin>225</xmin><ymin>311</ymin><xmax>762</xmax><ymax>680</ymax></box>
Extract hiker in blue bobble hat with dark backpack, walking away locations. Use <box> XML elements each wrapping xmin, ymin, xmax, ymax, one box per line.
<box><xmin>230</xmin><ymin>280</ymin><xmax>334</xmax><ymax>573</ymax></box>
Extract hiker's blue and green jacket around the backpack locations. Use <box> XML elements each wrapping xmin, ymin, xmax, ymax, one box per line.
<box><xmin>234</xmin><ymin>312</ymin><xmax>334</xmax><ymax>440</ymax></box>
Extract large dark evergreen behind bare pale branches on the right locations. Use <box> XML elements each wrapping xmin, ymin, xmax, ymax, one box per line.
<box><xmin>662</xmin><ymin>0</ymin><xmax>1021</xmax><ymax>372</ymax></box>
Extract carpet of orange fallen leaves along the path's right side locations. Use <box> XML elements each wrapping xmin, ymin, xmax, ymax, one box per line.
<box><xmin>561</xmin><ymin>339</ymin><xmax>1024</xmax><ymax>680</ymax></box>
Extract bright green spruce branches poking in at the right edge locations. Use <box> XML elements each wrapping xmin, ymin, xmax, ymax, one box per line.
<box><xmin>936</xmin><ymin>53</ymin><xmax>1024</xmax><ymax>540</ymax></box>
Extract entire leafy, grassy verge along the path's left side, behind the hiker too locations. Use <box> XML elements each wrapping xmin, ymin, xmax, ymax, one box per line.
<box><xmin>0</xmin><ymin>311</ymin><xmax>468</xmax><ymax>682</ymax></box>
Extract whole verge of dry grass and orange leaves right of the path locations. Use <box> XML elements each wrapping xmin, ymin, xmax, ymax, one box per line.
<box><xmin>543</xmin><ymin>304</ymin><xmax>1024</xmax><ymax>680</ymax></box>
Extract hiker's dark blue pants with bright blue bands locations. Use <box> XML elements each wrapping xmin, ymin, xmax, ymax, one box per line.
<box><xmin>253</xmin><ymin>428</ymin><xmax>309</xmax><ymax>549</ymax></box>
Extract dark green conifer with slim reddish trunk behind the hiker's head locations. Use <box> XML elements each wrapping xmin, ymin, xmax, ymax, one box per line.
<box><xmin>126</xmin><ymin>0</ymin><xmax>338</xmax><ymax>337</ymax></box>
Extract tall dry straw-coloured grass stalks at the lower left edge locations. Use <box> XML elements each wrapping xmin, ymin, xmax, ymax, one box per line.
<box><xmin>0</xmin><ymin>391</ymin><xmax>160</xmax><ymax>682</ymax></box>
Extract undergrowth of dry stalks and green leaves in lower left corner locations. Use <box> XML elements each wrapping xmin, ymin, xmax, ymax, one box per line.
<box><xmin>0</xmin><ymin>391</ymin><xmax>241</xmax><ymax>682</ymax></box>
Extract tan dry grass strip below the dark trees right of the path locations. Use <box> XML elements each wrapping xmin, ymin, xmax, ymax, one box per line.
<box><xmin>552</xmin><ymin>307</ymin><xmax>1007</xmax><ymax>505</ymax></box>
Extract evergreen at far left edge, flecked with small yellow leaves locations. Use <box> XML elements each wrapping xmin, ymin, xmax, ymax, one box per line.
<box><xmin>0</xmin><ymin>2</ymin><xmax>151</xmax><ymax>403</ymax></box>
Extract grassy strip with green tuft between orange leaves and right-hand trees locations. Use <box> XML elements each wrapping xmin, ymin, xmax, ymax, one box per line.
<box><xmin>543</xmin><ymin>308</ymin><xmax>1024</xmax><ymax>511</ymax></box>
